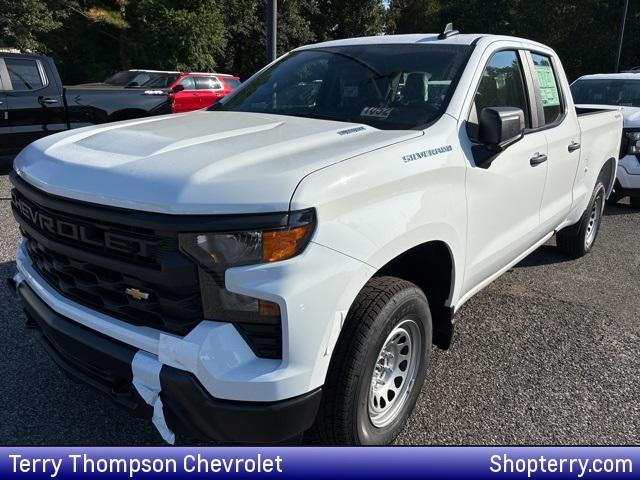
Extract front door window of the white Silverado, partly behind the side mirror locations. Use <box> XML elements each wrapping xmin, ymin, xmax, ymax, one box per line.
<box><xmin>467</xmin><ymin>50</ymin><xmax>531</xmax><ymax>140</ymax></box>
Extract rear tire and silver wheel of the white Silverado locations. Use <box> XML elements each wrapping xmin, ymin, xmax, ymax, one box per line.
<box><xmin>556</xmin><ymin>179</ymin><xmax>606</xmax><ymax>258</ymax></box>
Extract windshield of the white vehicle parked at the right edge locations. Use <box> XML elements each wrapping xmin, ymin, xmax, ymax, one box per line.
<box><xmin>571</xmin><ymin>78</ymin><xmax>640</xmax><ymax>107</ymax></box>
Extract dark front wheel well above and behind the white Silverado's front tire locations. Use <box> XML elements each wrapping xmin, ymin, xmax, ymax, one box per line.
<box><xmin>376</xmin><ymin>241</ymin><xmax>454</xmax><ymax>349</ymax></box>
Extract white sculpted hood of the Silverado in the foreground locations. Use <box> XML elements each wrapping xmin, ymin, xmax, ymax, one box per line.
<box><xmin>14</xmin><ymin>111</ymin><xmax>423</xmax><ymax>214</ymax></box>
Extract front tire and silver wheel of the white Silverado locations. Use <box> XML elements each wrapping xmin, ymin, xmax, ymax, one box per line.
<box><xmin>313</xmin><ymin>277</ymin><xmax>432</xmax><ymax>445</ymax></box>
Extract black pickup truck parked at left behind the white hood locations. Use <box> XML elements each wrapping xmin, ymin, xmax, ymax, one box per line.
<box><xmin>0</xmin><ymin>52</ymin><xmax>171</xmax><ymax>160</ymax></box>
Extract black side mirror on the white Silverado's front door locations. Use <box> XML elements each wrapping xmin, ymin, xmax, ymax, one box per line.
<box><xmin>478</xmin><ymin>107</ymin><xmax>525</xmax><ymax>151</ymax></box>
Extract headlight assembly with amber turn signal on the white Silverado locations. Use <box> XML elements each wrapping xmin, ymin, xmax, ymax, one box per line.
<box><xmin>179</xmin><ymin>209</ymin><xmax>316</xmax><ymax>346</ymax></box>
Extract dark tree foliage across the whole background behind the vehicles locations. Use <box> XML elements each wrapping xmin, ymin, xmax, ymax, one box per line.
<box><xmin>0</xmin><ymin>0</ymin><xmax>640</xmax><ymax>84</ymax></box>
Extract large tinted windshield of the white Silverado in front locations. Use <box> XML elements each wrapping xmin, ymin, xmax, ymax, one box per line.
<box><xmin>210</xmin><ymin>44</ymin><xmax>471</xmax><ymax>129</ymax></box>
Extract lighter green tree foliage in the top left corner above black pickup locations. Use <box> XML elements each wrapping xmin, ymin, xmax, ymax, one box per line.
<box><xmin>0</xmin><ymin>0</ymin><xmax>64</xmax><ymax>52</ymax></box>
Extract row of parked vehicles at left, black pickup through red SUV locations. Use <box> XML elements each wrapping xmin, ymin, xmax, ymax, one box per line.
<box><xmin>0</xmin><ymin>53</ymin><xmax>240</xmax><ymax>157</ymax></box>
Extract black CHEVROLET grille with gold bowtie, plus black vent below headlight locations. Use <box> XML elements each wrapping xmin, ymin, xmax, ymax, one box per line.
<box><xmin>11</xmin><ymin>174</ymin><xmax>282</xmax><ymax>358</ymax></box>
